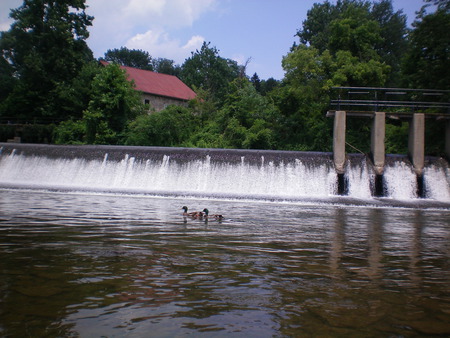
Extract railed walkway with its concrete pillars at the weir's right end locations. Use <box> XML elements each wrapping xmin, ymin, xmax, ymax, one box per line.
<box><xmin>327</xmin><ymin>87</ymin><xmax>450</xmax><ymax>197</ymax></box>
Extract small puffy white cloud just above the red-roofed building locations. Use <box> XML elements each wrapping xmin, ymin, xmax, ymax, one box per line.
<box><xmin>125</xmin><ymin>30</ymin><xmax>205</xmax><ymax>64</ymax></box>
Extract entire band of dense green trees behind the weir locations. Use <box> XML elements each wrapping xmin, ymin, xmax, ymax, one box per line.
<box><xmin>0</xmin><ymin>0</ymin><xmax>450</xmax><ymax>154</ymax></box>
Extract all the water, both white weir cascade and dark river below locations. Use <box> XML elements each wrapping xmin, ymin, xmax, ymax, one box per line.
<box><xmin>0</xmin><ymin>144</ymin><xmax>450</xmax><ymax>337</ymax></box>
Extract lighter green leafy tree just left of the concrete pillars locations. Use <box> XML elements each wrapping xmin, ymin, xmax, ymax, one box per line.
<box><xmin>278</xmin><ymin>45</ymin><xmax>336</xmax><ymax>151</ymax></box>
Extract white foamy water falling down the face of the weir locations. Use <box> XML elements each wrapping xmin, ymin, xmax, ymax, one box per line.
<box><xmin>0</xmin><ymin>152</ymin><xmax>450</xmax><ymax>202</ymax></box>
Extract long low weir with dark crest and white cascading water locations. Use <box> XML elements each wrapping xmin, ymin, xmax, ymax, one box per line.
<box><xmin>0</xmin><ymin>143</ymin><xmax>450</xmax><ymax>203</ymax></box>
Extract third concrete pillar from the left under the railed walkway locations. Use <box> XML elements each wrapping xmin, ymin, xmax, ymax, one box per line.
<box><xmin>408</xmin><ymin>113</ymin><xmax>425</xmax><ymax>176</ymax></box>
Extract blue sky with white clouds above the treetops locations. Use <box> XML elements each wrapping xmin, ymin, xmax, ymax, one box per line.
<box><xmin>0</xmin><ymin>0</ymin><xmax>424</xmax><ymax>80</ymax></box>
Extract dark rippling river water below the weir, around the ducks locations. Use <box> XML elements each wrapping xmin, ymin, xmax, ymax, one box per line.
<box><xmin>0</xmin><ymin>188</ymin><xmax>450</xmax><ymax>337</ymax></box>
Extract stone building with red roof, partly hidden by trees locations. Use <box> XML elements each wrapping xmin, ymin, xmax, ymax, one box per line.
<box><xmin>100</xmin><ymin>61</ymin><xmax>196</xmax><ymax>111</ymax></box>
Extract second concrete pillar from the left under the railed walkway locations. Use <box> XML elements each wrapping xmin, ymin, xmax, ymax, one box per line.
<box><xmin>370</xmin><ymin>112</ymin><xmax>386</xmax><ymax>175</ymax></box>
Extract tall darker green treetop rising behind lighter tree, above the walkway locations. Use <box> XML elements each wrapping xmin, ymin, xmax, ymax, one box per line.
<box><xmin>294</xmin><ymin>0</ymin><xmax>408</xmax><ymax>85</ymax></box>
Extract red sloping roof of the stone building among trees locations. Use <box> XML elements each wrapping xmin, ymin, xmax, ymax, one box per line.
<box><xmin>100</xmin><ymin>61</ymin><xmax>196</xmax><ymax>101</ymax></box>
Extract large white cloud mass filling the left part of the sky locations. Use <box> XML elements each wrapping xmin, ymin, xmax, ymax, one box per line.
<box><xmin>87</xmin><ymin>0</ymin><xmax>217</xmax><ymax>59</ymax></box>
